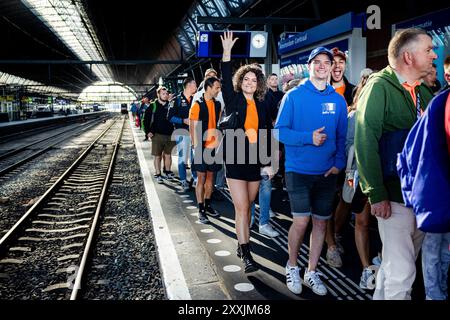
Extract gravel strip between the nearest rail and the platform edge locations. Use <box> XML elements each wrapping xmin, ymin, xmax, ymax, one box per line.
<box><xmin>82</xmin><ymin>121</ymin><xmax>166</xmax><ymax>300</ymax></box>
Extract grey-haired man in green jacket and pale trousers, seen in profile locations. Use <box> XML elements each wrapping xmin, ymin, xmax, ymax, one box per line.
<box><xmin>355</xmin><ymin>28</ymin><xmax>437</xmax><ymax>300</ymax></box>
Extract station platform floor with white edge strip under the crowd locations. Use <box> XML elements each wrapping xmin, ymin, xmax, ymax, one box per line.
<box><xmin>125</xmin><ymin>114</ymin><xmax>390</xmax><ymax>300</ymax></box>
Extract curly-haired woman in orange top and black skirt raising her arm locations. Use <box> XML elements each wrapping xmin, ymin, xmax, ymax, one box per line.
<box><xmin>221</xmin><ymin>31</ymin><xmax>273</xmax><ymax>273</ymax></box>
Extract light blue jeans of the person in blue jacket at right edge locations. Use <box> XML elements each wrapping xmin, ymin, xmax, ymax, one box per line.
<box><xmin>422</xmin><ymin>232</ymin><xmax>450</xmax><ymax>300</ymax></box>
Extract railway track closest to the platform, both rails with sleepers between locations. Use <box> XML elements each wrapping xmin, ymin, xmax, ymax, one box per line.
<box><xmin>0</xmin><ymin>115</ymin><xmax>125</xmax><ymax>300</ymax></box>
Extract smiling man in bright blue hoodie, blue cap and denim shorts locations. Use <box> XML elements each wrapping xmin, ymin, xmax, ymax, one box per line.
<box><xmin>275</xmin><ymin>47</ymin><xmax>347</xmax><ymax>295</ymax></box>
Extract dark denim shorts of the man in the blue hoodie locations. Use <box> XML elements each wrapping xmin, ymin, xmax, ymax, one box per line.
<box><xmin>286</xmin><ymin>172</ymin><xmax>337</xmax><ymax>220</ymax></box>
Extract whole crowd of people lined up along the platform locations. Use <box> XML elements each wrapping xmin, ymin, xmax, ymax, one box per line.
<box><xmin>131</xmin><ymin>28</ymin><xmax>450</xmax><ymax>300</ymax></box>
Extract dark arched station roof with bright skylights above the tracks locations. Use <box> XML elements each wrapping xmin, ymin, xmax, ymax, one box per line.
<box><xmin>0</xmin><ymin>0</ymin><xmax>442</xmax><ymax>100</ymax></box>
